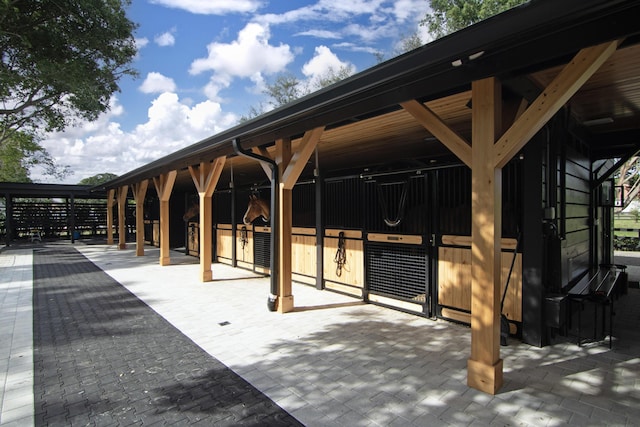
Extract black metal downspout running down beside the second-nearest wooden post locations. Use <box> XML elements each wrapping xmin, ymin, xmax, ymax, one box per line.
<box><xmin>231</xmin><ymin>139</ymin><xmax>278</xmax><ymax>311</ymax></box>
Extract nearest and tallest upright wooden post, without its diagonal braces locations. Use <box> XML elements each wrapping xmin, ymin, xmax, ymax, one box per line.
<box><xmin>467</xmin><ymin>78</ymin><xmax>503</xmax><ymax>394</ymax></box>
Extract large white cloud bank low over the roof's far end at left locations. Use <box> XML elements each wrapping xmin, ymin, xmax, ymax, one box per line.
<box><xmin>31</xmin><ymin>93</ymin><xmax>238</xmax><ymax>183</ymax></box>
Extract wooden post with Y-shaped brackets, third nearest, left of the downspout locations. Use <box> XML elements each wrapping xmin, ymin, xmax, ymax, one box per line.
<box><xmin>189</xmin><ymin>157</ymin><xmax>226</xmax><ymax>282</ymax></box>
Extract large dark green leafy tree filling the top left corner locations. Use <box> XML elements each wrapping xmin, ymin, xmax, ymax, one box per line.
<box><xmin>0</xmin><ymin>0</ymin><xmax>136</xmax><ymax>144</ymax></box>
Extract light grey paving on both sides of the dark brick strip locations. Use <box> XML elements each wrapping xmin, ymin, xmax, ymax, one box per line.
<box><xmin>0</xmin><ymin>245</ymin><xmax>640</xmax><ymax>426</ymax></box>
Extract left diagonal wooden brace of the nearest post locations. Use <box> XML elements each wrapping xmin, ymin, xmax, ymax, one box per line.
<box><xmin>400</xmin><ymin>100</ymin><xmax>471</xmax><ymax>167</ymax></box>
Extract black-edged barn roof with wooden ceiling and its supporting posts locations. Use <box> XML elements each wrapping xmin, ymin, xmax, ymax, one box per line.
<box><xmin>100</xmin><ymin>0</ymin><xmax>640</xmax><ymax>394</ymax></box>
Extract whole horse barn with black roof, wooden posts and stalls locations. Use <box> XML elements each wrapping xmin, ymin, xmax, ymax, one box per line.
<box><xmin>91</xmin><ymin>0</ymin><xmax>640</xmax><ymax>393</ymax></box>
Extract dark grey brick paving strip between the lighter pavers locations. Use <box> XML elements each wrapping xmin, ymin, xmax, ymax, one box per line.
<box><xmin>33</xmin><ymin>246</ymin><xmax>301</xmax><ymax>426</ymax></box>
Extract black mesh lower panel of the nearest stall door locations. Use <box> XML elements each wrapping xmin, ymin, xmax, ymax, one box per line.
<box><xmin>367</xmin><ymin>242</ymin><xmax>428</xmax><ymax>304</ymax></box>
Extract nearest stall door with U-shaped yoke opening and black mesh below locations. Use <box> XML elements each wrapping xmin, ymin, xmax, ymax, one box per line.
<box><xmin>363</xmin><ymin>171</ymin><xmax>432</xmax><ymax>316</ymax></box>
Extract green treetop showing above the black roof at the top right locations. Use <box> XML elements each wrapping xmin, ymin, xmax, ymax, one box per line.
<box><xmin>421</xmin><ymin>0</ymin><xmax>528</xmax><ymax>39</ymax></box>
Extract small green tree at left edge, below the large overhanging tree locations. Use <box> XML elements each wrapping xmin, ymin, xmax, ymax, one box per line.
<box><xmin>0</xmin><ymin>132</ymin><xmax>71</xmax><ymax>182</ymax></box>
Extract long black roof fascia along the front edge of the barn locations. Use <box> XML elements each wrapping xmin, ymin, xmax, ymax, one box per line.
<box><xmin>105</xmin><ymin>0</ymin><xmax>640</xmax><ymax>188</ymax></box>
